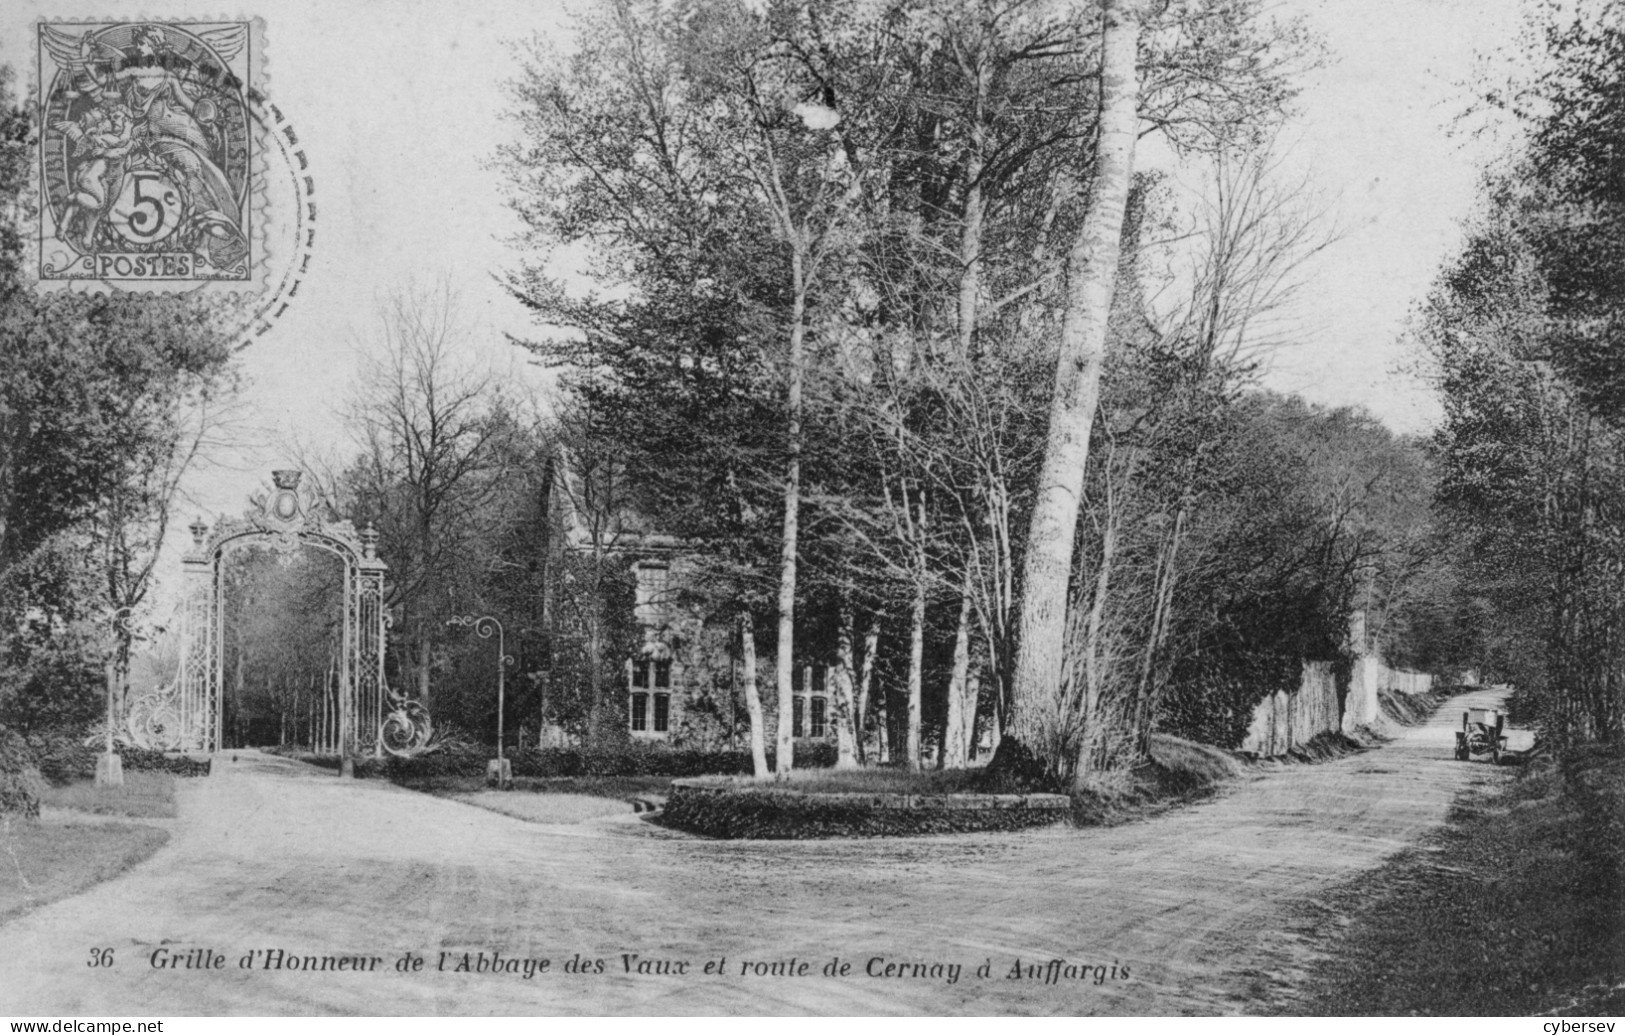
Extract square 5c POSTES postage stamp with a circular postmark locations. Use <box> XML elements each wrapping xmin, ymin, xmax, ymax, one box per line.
<box><xmin>37</xmin><ymin>21</ymin><xmax>265</xmax><ymax>291</ymax></box>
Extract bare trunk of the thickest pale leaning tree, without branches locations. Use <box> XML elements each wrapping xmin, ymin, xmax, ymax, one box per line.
<box><xmin>1009</xmin><ymin>0</ymin><xmax>1142</xmax><ymax>777</ymax></box>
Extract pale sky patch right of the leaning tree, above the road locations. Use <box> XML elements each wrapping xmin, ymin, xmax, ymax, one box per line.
<box><xmin>1241</xmin><ymin>0</ymin><xmax>1521</xmax><ymax>432</ymax></box>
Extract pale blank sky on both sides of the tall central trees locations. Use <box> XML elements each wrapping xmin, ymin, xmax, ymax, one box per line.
<box><xmin>0</xmin><ymin>0</ymin><xmax>1518</xmax><ymax>604</ymax></box>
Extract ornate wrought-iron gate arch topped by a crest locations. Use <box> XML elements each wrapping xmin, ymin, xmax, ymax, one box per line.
<box><xmin>127</xmin><ymin>470</ymin><xmax>429</xmax><ymax>757</ymax></box>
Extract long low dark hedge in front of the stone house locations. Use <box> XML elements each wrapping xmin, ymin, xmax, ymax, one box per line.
<box><xmin>310</xmin><ymin>741</ymin><xmax>835</xmax><ymax>783</ymax></box>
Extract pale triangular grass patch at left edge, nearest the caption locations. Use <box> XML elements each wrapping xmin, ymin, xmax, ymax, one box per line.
<box><xmin>0</xmin><ymin>817</ymin><xmax>169</xmax><ymax>923</ymax></box>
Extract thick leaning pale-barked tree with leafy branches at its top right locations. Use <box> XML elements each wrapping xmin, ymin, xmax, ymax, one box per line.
<box><xmin>1004</xmin><ymin>0</ymin><xmax>1302</xmax><ymax>782</ymax></box>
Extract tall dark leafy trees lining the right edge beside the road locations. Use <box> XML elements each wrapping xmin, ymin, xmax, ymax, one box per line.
<box><xmin>1419</xmin><ymin>2</ymin><xmax>1625</xmax><ymax>741</ymax></box>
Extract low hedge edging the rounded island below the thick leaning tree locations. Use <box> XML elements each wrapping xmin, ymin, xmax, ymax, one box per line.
<box><xmin>657</xmin><ymin>785</ymin><xmax>1068</xmax><ymax>840</ymax></box>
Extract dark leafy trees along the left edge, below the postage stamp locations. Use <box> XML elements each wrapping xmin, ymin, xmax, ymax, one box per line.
<box><xmin>0</xmin><ymin>68</ymin><xmax>232</xmax><ymax>730</ymax></box>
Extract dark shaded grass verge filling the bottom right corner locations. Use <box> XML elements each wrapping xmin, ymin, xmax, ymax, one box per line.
<box><xmin>1274</xmin><ymin>752</ymin><xmax>1625</xmax><ymax>1016</ymax></box>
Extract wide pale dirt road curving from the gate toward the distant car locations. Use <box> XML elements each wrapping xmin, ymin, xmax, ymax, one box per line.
<box><xmin>0</xmin><ymin>692</ymin><xmax>1518</xmax><ymax>1019</ymax></box>
